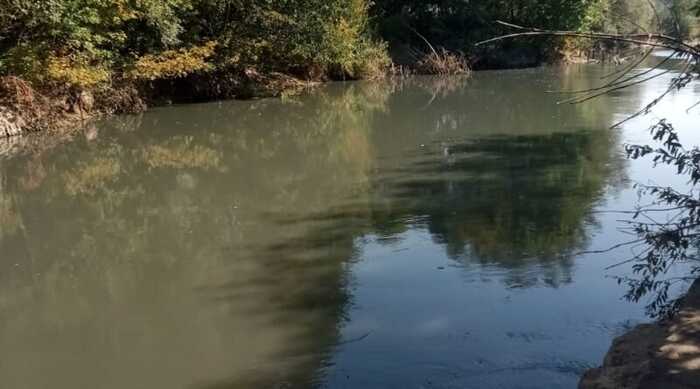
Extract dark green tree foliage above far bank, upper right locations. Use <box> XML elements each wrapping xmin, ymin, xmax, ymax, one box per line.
<box><xmin>373</xmin><ymin>0</ymin><xmax>697</xmax><ymax>62</ymax></box>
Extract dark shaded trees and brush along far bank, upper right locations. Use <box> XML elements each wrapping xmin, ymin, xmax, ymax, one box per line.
<box><xmin>372</xmin><ymin>0</ymin><xmax>694</xmax><ymax>69</ymax></box>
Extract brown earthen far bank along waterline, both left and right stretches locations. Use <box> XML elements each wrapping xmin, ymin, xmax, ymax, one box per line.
<box><xmin>0</xmin><ymin>50</ymin><xmax>590</xmax><ymax>138</ymax></box>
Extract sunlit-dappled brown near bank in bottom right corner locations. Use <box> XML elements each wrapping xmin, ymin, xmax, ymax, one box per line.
<box><xmin>579</xmin><ymin>280</ymin><xmax>700</xmax><ymax>389</ymax></box>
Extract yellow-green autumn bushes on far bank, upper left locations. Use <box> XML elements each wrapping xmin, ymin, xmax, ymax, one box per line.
<box><xmin>0</xmin><ymin>0</ymin><xmax>389</xmax><ymax>87</ymax></box>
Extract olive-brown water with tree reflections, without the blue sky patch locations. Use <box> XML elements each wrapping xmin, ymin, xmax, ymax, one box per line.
<box><xmin>0</xmin><ymin>69</ymin><xmax>624</xmax><ymax>389</ymax></box>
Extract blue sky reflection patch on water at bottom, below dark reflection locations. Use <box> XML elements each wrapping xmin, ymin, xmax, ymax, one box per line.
<box><xmin>328</xmin><ymin>230</ymin><xmax>639</xmax><ymax>388</ymax></box>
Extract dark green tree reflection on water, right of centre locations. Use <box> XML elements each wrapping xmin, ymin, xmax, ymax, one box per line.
<box><xmin>268</xmin><ymin>127</ymin><xmax>623</xmax><ymax>287</ymax></box>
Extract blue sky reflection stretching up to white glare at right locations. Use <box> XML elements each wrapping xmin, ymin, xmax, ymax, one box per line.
<box><xmin>327</xmin><ymin>67</ymin><xmax>700</xmax><ymax>388</ymax></box>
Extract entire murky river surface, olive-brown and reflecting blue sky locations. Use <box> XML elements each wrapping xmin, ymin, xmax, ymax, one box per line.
<box><xmin>0</xmin><ymin>62</ymin><xmax>697</xmax><ymax>389</ymax></box>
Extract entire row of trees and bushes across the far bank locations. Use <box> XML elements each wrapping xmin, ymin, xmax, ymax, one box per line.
<box><xmin>0</xmin><ymin>0</ymin><xmax>691</xmax><ymax>99</ymax></box>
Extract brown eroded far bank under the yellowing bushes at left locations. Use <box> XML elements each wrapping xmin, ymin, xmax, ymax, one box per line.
<box><xmin>0</xmin><ymin>70</ymin><xmax>319</xmax><ymax>138</ymax></box>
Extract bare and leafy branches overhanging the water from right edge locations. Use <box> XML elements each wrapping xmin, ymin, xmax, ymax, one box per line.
<box><xmin>478</xmin><ymin>16</ymin><xmax>700</xmax><ymax>317</ymax></box>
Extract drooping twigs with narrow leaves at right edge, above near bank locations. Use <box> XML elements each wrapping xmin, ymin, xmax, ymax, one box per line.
<box><xmin>618</xmin><ymin>117</ymin><xmax>700</xmax><ymax>317</ymax></box>
